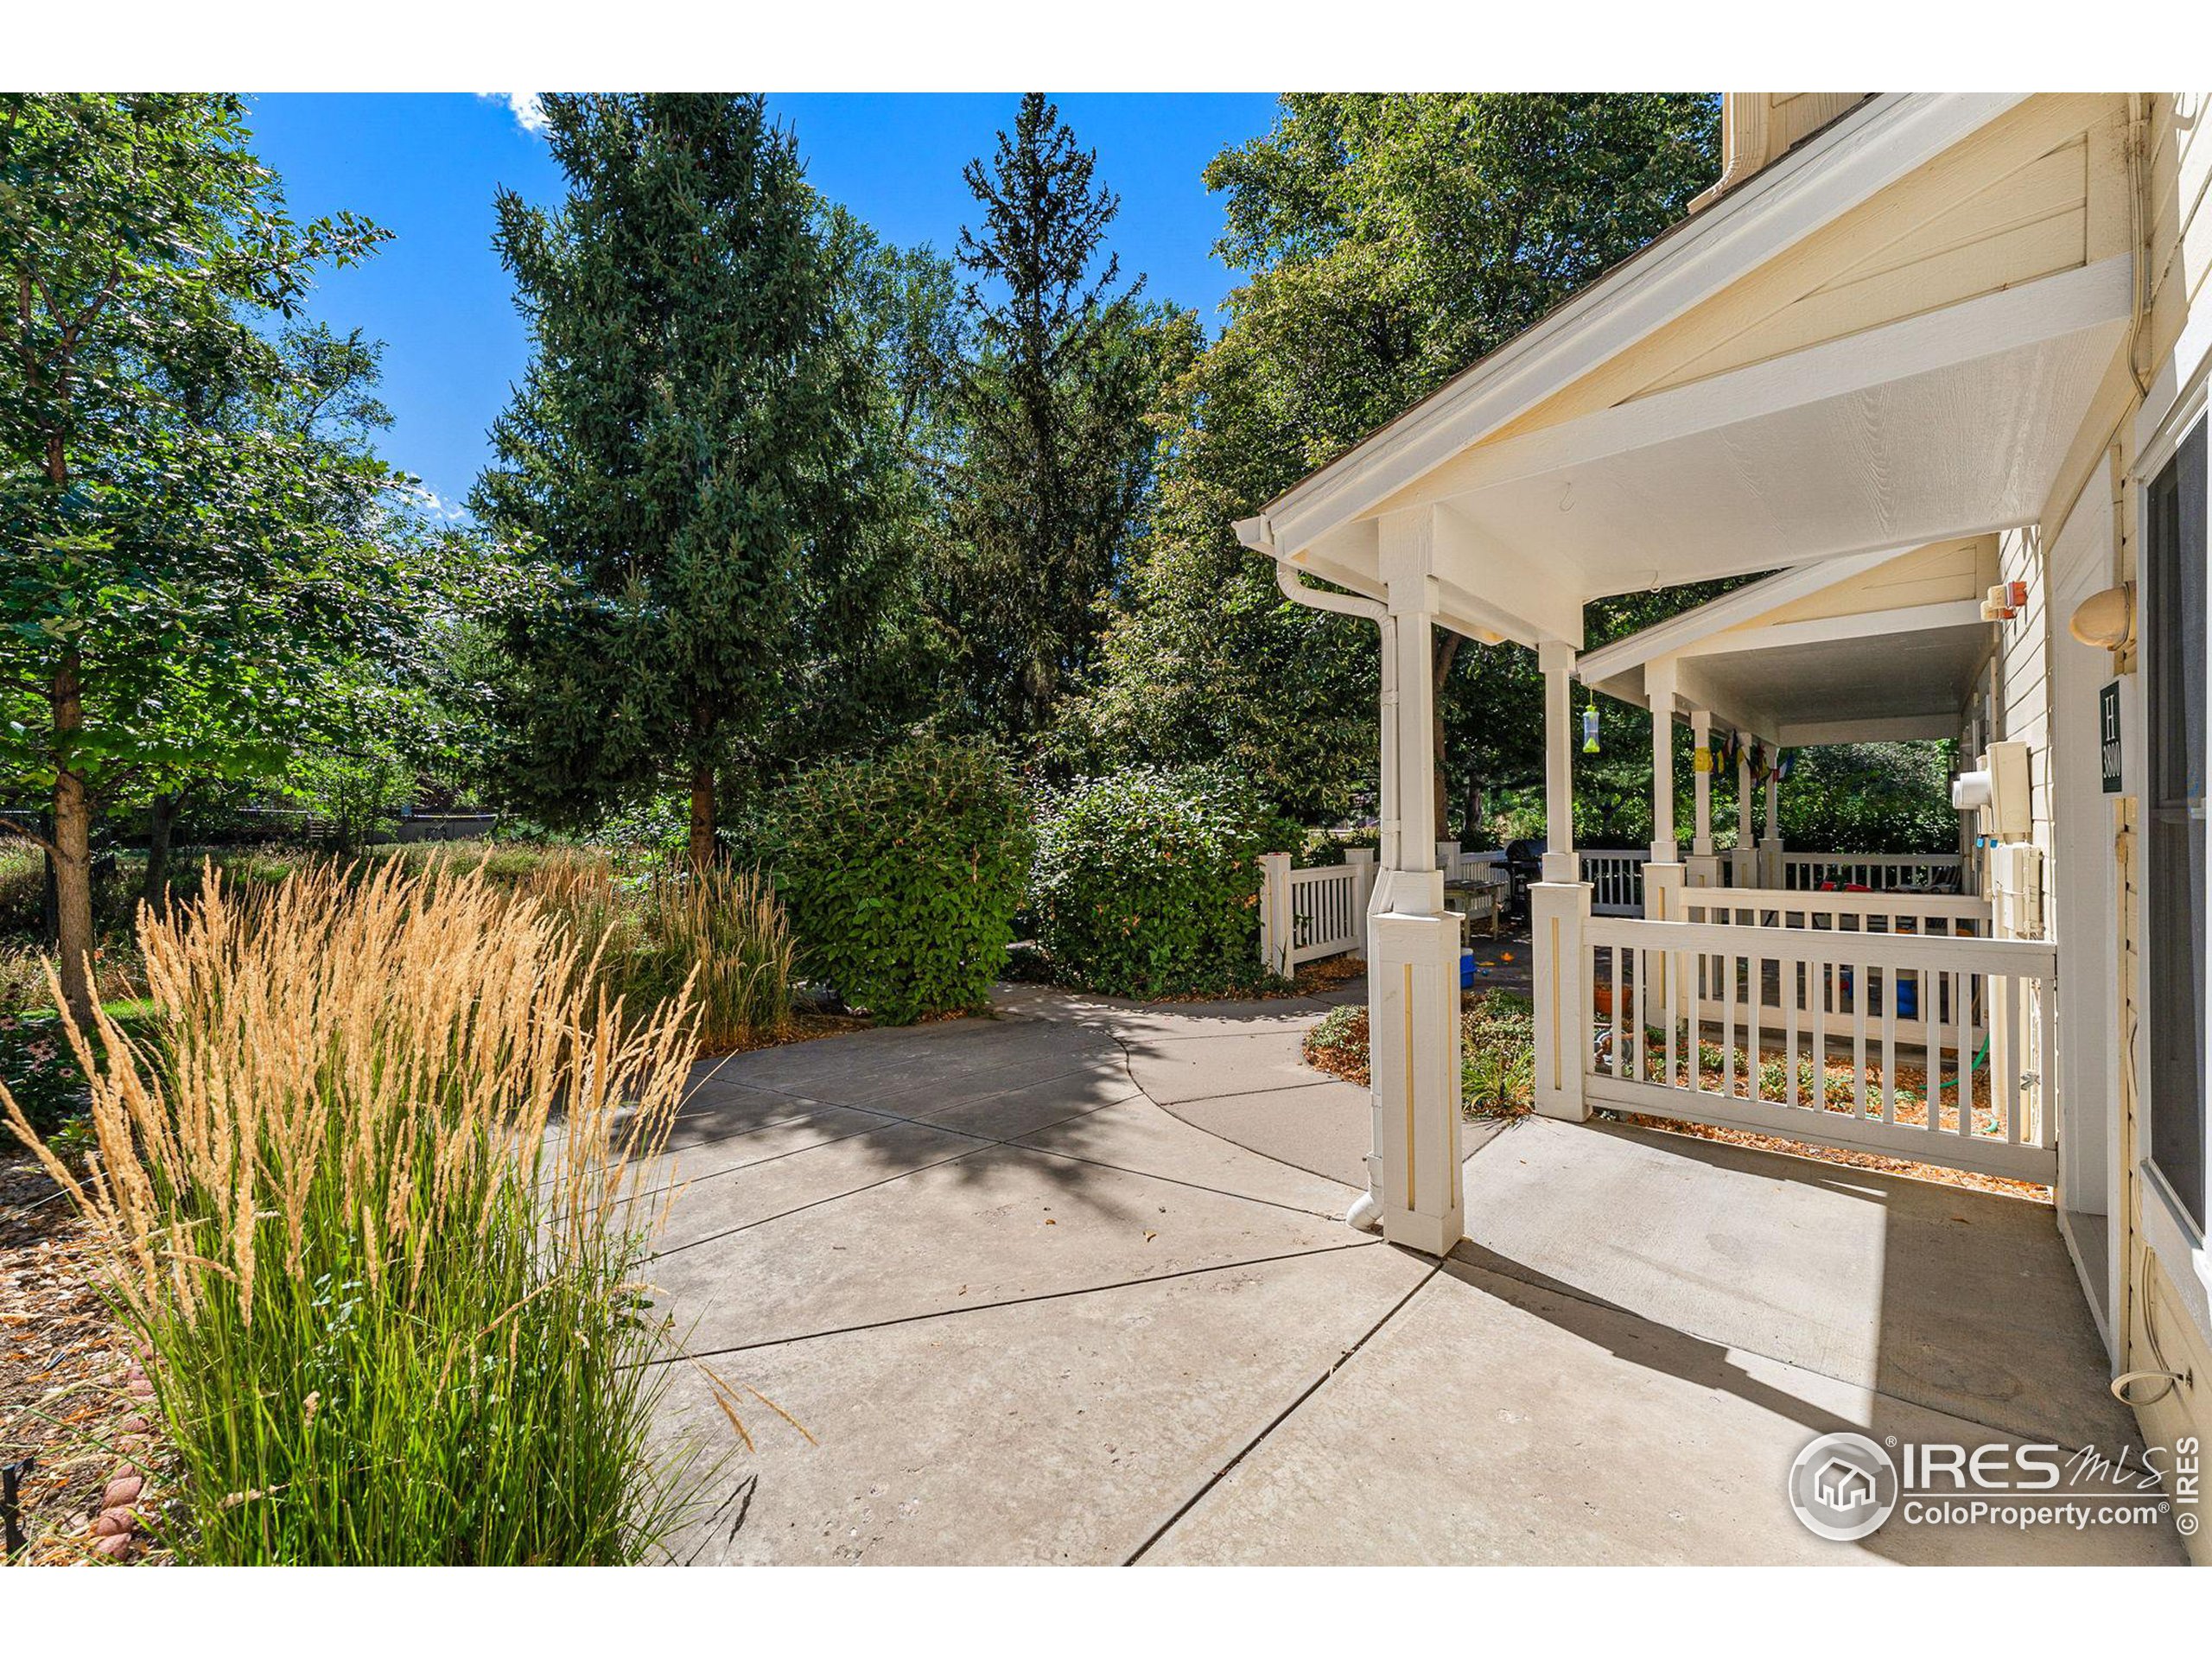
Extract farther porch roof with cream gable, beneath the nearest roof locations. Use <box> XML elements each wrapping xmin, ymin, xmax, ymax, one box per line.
<box><xmin>1575</xmin><ymin>536</ymin><xmax>1998</xmax><ymax>747</ymax></box>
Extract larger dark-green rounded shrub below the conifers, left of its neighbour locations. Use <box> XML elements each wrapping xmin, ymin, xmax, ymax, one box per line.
<box><xmin>759</xmin><ymin>739</ymin><xmax>1031</xmax><ymax>1024</ymax></box>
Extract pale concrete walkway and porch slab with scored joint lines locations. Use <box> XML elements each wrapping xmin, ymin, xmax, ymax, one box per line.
<box><xmin>655</xmin><ymin>988</ymin><xmax>2179</xmax><ymax>1564</ymax></box>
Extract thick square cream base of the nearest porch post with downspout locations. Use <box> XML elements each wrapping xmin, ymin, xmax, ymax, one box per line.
<box><xmin>1344</xmin><ymin>911</ymin><xmax>1466</xmax><ymax>1256</ymax></box>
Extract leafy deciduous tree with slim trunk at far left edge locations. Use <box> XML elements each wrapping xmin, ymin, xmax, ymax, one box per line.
<box><xmin>0</xmin><ymin>95</ymin><xmax>383</xmax><ymax>1018</ymax></box>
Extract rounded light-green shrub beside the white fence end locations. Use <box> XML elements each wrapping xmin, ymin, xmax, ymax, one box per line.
<box><xmin>1031</xmin><ymin>767</ymin><xmax>1287</xmax><ymax>998</ymax></box>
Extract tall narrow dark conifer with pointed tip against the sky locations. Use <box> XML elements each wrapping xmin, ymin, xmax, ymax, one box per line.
<box><xmin>938</xmin><ymin>93</ymin><xmax>1197</xmax><ymax>736</ymax></box>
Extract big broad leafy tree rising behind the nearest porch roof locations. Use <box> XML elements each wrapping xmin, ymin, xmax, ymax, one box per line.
<box><xmin>1058</xmin><ymin>93</ymin><xmax>1719</xmax><ymax>827</ymax></box>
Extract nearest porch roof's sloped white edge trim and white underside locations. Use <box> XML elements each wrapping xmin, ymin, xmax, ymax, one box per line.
<box><xmin>1239</xmin><ymin>93</ymin><xmax>2133</xmax><ymax>654</ymax></box>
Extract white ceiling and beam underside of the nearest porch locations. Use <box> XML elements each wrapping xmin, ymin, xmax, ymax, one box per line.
<box><xmin>1276</xmin><ymin>259</ymin><xmax>2133</xmax><ymax>652</ymax></box>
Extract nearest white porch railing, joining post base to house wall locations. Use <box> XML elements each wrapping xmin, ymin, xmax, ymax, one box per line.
<box><xmin>1577</xmin><ymin>915</ymin><xmax>2057</xmax><ymax>1181</ymax></box>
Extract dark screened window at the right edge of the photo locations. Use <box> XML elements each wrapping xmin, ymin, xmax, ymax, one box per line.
<box><xmin>2144</xmin><ymin>420</ymin><xmax>2205</xmax><ymax>1230</ymax></box>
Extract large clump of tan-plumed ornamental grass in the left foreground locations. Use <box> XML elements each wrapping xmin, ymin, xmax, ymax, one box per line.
<box><xmin>0</xmin><ymin>865</ymin><xmax>696</xmax><ymax>1564</ymax></box>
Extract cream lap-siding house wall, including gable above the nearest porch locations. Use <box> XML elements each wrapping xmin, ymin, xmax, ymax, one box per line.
<box><xmin>1672</xmin><ymin>93</ymin><xmax>2212</xmax><ymax>1564</ymax></box>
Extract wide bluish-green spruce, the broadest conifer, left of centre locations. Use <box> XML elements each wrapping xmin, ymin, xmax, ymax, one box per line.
<box><xmin>474</xmin><ymin>93</ymin><xmax>902</xmax><ymax>862</ymax></box>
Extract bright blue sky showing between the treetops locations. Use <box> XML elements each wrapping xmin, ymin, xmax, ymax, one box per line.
<box><xmin>252</xmin><ymin>93</ymin><xmax>1274</xmax><ymax>502</ymax></box>
